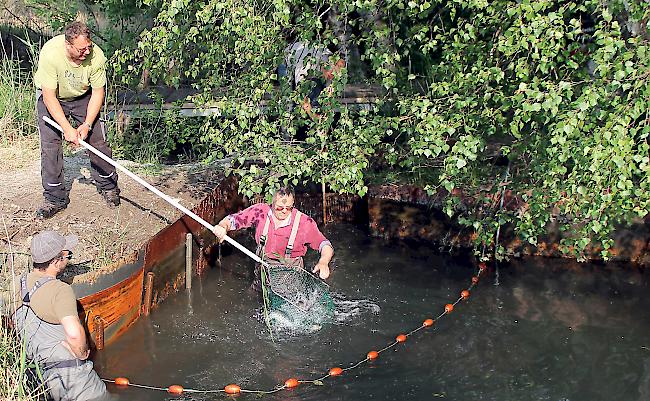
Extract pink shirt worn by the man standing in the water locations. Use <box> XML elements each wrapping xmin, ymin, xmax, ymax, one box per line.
<box><xmin>228</xmin><ymin>203</ymin><xmax>332</xmax><ymax>259</ymax></box>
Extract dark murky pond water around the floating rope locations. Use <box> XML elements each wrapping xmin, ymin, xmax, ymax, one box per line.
<box><xmin>96</xmin><ymin>225</ymin><xmax>650</xmax><ymax>401</ymax></box>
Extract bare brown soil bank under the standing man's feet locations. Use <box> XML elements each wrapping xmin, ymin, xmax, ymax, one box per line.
<box><xmin>0</xmin><ymin>146</ymin><xmax>222</xmax><ymax>288</ymax></box>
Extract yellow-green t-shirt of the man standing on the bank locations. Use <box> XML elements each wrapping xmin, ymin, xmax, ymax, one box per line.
<box><xmin>34</xmin><ymin>35</ymin><xmax>106</xmax><ymax>100</ymax></box>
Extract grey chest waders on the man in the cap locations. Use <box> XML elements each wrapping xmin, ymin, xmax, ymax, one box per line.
<box><xmin>14</xmin><ymin>275</ymin><xmax>107</xmax><ymax>401</ymax></box>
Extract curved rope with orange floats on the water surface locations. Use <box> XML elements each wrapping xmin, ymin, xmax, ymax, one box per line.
<box><xmin>102</xmin><ymin>263</ymin><xmax>487</xmax><ymax>395</ymax></box>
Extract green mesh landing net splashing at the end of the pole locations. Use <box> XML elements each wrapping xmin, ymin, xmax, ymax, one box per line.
<box><xmin>263</xmin><ymin>265</ymin><xmax>334</xmax><ymax>326</ymax></box>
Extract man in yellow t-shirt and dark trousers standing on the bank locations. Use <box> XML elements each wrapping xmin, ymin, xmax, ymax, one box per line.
<box><xmin>34</xmin><ymin>22</ymin><xmax>120</xmax><ymax>219</ymax></box>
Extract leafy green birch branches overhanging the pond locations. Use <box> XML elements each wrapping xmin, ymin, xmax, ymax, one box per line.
<box><xmin>115</xmin><ymin>0</ymin><xmax>650</xmax><ymax>258</ymax></box>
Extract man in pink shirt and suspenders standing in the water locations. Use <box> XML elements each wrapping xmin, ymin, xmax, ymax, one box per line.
<box><xmin>213</xmin><ymin>187</ymin><xmax>334</xmax><ymax>291</ymax></box>
